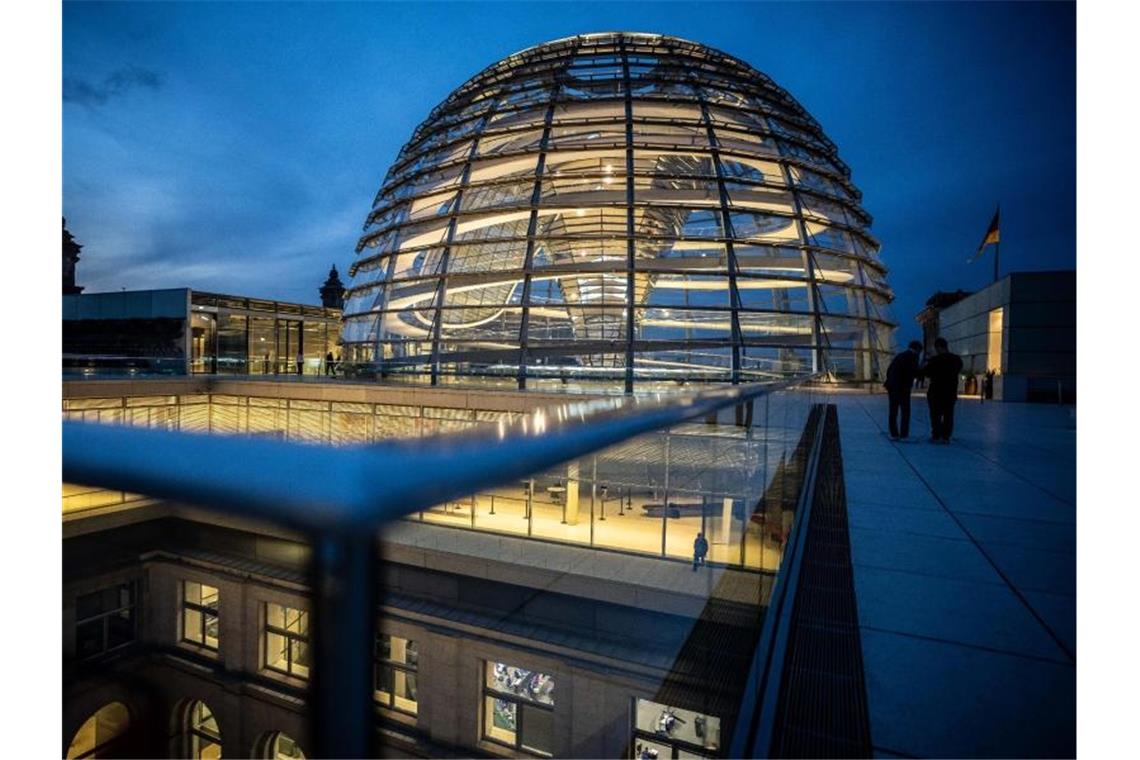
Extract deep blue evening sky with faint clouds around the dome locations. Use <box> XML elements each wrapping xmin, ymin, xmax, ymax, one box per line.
<box><xmin>63</xmin><ymin>2</ymin><xmax>1076</xmax><ymax>332</ymax></box>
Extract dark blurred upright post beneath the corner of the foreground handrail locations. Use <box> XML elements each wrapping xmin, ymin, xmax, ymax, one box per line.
<box><xmin>309</xmin><ymin>526</ymin><xmax>377</xmax><ymax>758</ymax></box>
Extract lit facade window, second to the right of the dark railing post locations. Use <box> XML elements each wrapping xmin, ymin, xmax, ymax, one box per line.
<box><xmin>483</xmin><ymin>662</ymin><xmax>554</xmax><ymax>755</ymax></box>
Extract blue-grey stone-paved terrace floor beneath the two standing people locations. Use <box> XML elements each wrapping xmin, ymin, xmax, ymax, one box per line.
<box><xmin>833</xmin><ymin>394</ymin><xmax>1076</xmax><ymax>757</ymax></box>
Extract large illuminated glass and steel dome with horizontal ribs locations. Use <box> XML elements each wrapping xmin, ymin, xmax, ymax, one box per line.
<box><xmin>342</xmin><ymin>33</ymin><xmax>894</xmax><ymax>391</ymax></box>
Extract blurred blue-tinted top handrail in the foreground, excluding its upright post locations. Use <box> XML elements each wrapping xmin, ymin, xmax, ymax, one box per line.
<box><xmin>63</xmin><ymin>375</ymin><xmax>819</xmax><ymax>530</ymax></box>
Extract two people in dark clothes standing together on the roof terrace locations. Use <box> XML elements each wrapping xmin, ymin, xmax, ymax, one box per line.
<box><xmin>884</xmin><ymin>337</ymin><xmax>962</xmax><ymax>443</ymax></box>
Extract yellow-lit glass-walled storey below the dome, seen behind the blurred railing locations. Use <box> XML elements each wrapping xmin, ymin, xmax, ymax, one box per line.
<box><xmin>63</xmin><ymin>377</ymin><xmax>812</xmax><ymax>571</ymax></box>
